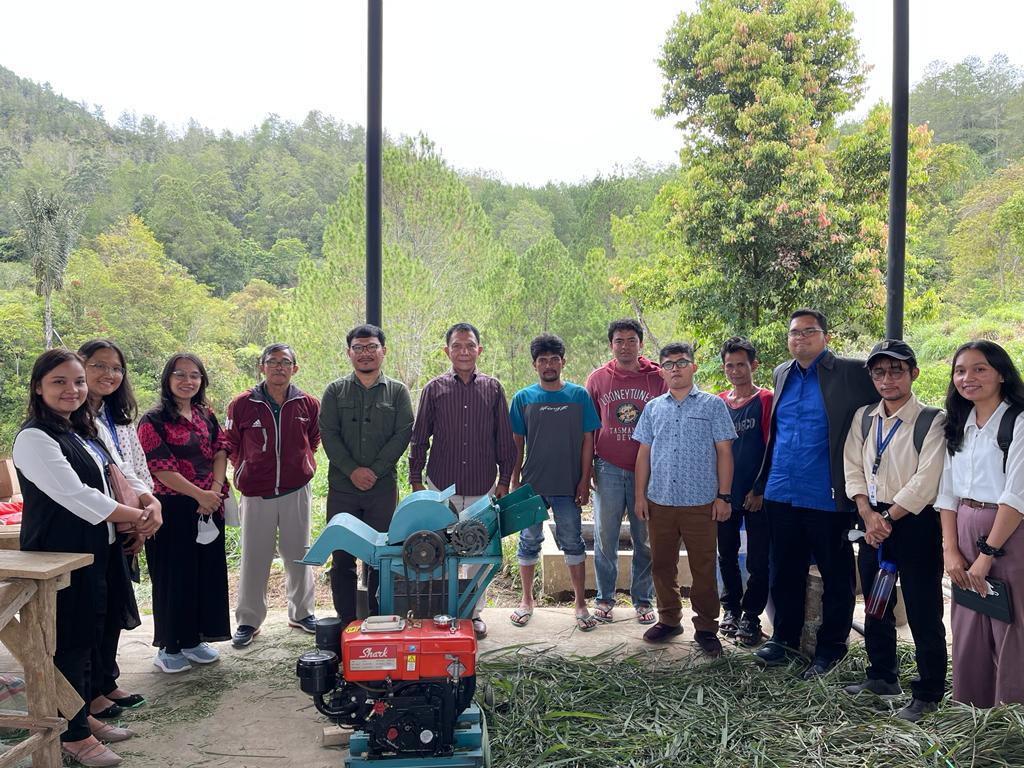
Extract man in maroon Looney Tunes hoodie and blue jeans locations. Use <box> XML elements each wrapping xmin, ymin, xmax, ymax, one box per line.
<box><xmin>587</xmin><ymin>318</ymin><xmax>666</xmax><ymax>624</ymax></box>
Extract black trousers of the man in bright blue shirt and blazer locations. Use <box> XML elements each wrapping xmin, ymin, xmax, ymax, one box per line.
<box><xmin>765</xmin><ymin>499</ymin><xmax>856</xmax><ymax>664</ymax></box>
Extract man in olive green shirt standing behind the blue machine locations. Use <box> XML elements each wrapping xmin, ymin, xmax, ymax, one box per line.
<box><xmin>319</xmin><ymin>325</ymin><xmax>413</xmax><ymax>624</ymax></box>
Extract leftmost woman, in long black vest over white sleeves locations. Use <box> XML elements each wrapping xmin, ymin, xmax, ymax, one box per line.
<box><xmin>13</xmin><ymin>349</ymin><xmax>162</xmax><ymax>766</ymax></box>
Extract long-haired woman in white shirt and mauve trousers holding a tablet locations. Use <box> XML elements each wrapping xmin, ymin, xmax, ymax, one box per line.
<box><xmin>935</xmin><ymin>340</ymin><xmax>1024</xmax><ymax>708</ymax></box>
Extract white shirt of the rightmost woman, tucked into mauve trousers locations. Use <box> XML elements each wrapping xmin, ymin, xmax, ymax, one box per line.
<box><xmin>935</xmin><ymin>401</ymin><xmax>1024</xmax><ymax>514</ymax></box>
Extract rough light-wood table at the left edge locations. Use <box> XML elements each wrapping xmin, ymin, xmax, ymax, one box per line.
<box><xmin>0</xmin><ymin>550</ymin><xmax>92</xmax><ymax>768</ymax></box>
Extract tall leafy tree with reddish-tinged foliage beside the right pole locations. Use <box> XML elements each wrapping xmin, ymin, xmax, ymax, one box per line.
<box><xmin>658</xmin><ymin>0</ymin><xmax>864</xmax><ymax>354</ymax></box>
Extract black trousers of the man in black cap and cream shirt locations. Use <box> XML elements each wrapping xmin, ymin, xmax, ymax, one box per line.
<box><xmin>857</xmin><ymin>505</ymin><xmax>946</xmax><ymax>701</ymax></box>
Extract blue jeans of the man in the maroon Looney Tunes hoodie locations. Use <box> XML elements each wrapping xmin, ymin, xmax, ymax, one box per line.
<box><xmin>594</xmin><ymin>459</ymin><xmax>654</xmax><ymax>605</ymax></box>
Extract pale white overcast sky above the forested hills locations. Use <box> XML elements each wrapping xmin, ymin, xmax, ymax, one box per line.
<box><xmin>0</xmin><ymin>0</ymin><xmax>1024</xmax><ymax>184</ymax></box>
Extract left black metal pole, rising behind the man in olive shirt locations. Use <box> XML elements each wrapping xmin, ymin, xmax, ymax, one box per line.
<box><xmin>367</xmin><ymin>0</ymin><xmax>384</xmax><ymax>326</ymax></box>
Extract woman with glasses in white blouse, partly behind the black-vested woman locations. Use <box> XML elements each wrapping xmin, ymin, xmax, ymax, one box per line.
<box><xmin>78</xmin><ymin>339</ymin><xmax>153</xmax><ymax>719</ymax></box>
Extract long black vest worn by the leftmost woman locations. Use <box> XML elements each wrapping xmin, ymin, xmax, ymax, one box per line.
<box><xmin>17</xmin><ymin>420</ymin><xmax>139</xmax><ymax>650</ymax></box>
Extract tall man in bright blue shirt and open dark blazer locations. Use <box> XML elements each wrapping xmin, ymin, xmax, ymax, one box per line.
<box><xmin>755</xmin><ymin>309</ymin><xmax>879</xmax><ymax>678</ymax></box>
